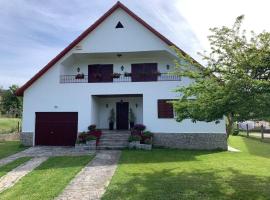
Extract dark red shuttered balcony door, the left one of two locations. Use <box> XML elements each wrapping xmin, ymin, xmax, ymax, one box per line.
<box><xmin>88</xmin><ymin>64</ymin><xmax>113</xmax><ymax>83</ymax></box>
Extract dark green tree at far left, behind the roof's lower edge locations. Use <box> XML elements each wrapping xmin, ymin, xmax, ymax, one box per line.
<box><xmin>1</xmin><ymin>85</ymin><xmax>22</xmax><ymax>117</ymax></box>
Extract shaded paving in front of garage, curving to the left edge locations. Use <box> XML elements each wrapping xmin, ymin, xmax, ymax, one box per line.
<box><xmin>0</xmin><ymin>146</ymin><xmax>94</xmax><ymax>167</ymax></box>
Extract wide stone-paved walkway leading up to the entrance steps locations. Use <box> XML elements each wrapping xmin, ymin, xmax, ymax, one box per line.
<box><xmin>57</xmin><ymin>151</ymin><xmax>121</xmax><ymax>200</ymax></box>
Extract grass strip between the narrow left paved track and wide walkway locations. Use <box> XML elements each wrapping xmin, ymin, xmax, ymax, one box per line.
<box><xmin>0</xmin><ymin>156</ymin><xmax>92</xmax><ymax>200</ymax></box>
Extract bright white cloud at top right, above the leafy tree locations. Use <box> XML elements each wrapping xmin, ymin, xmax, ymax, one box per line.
<box><xmin>176</xmin><ymin>0</ymin><xmax>270</xmax><ymax>49</ymax></box>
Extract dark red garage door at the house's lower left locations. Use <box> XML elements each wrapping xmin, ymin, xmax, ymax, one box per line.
<box><xmin>35</xmin><ymin>112</ymin><xmax>78</xmax><ymax>146</ymax></box>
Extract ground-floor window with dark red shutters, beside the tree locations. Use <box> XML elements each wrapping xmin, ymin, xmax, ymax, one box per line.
<box><xmin>158</xmin><ymin>99</ymin><xmax>174</xmax><ymax>118</ymax></box>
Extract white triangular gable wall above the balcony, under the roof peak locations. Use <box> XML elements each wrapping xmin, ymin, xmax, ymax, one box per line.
<box><xmin>73</xmin><ymin>9</ymin><xmax>171</xmax><ymax>53</ymax></box>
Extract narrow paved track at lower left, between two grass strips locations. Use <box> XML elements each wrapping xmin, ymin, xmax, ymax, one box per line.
<box><xmin>0</xmin><ymin>157</ymin><xmax>47</xmax><ymax>193</ymax></box>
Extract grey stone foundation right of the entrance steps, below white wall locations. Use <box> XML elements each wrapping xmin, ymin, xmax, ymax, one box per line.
<box><xmin>153</xmin><ymin>133</ymin><xmax>227</xmax><ymax>150</ymax></box>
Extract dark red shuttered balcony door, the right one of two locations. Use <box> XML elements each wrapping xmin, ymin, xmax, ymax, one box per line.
<box><xmin>131</xmin><ymin>63</ymin><xmax>158</xmax><ymax>82</ymax></box>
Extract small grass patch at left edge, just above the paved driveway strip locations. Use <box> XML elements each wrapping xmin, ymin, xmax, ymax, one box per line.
<box><xmin>0</xmin><ymin>141</ymin><xmax>27</xmax><ymax>159</ymax></box>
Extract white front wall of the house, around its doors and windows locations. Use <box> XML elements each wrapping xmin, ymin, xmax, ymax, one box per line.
<box><xmin>22</xmin><ymin>5</ymin><xmax>225</xmax><ymax>145</ymax></box>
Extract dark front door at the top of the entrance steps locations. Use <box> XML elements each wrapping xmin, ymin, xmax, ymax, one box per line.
<box><xmin>116</xmin><ymin>102</ymin><xmax>129</xmax><ymax>130</ymax></box>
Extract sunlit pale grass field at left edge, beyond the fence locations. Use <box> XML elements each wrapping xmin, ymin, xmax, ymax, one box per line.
<box><xmin>0</xmin><ymin>118</ymin><xmax>20</xmax><ymax>134</ymax></box>
